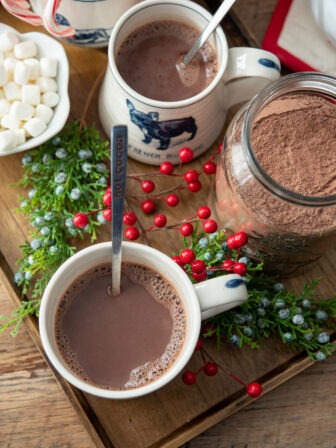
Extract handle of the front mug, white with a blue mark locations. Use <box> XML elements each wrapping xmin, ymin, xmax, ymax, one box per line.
<box><xmin>193</xmin><ymin>274</ymin><xmax>248</xmax><ymax>320</ymax></box>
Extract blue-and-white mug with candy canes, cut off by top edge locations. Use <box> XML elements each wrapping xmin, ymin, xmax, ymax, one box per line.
<box><xmin>1</xmin><ymin>0</ymin><xmax>142</xmax><ymax>47</ymax></box>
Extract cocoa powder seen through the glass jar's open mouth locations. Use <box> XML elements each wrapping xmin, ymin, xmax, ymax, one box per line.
<box><xmin>252</xmin><ymin>94</ymin><xmax>336</xmax><ymax>197</ymax></box>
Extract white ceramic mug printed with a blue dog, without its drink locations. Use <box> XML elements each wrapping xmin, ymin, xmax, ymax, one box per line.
<box><xmin>99</xmin><ymin>0</ymin><xmax>280</xmax><ymax>165</ymax></box>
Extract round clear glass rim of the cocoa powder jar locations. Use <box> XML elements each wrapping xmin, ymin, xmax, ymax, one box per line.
<box><xmin>241</xmin><ymin>72</ymin><xmax>336</xmax><ymax>207</ymax></box>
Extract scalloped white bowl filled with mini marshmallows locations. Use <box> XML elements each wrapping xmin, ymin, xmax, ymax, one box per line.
<box><xmin>0</xmin><ymin>23</ymin><xmax>70</xmax><ymax>156</ymax></box>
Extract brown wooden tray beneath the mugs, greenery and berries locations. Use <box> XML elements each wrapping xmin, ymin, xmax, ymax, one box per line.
<box><xmin>0</xmin><ymin>7</ymin><xmax>336</xmax><ymax>448</ymax></box>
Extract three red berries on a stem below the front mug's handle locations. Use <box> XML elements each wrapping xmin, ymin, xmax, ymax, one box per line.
<box><xmin>182</xmin><ymin>339</ymin><xmax>262</xmax><ymax>398</ymax></box>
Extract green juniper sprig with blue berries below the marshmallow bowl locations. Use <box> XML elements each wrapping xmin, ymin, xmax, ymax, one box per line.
<box><xmin>0</xmin><ymin>122</ymin><xmax>109</xmax><ymax>335</ymax></box>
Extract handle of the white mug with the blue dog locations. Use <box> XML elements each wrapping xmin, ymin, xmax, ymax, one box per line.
<box><xmin>223</xmin><ymin>47</ymin><xmax>281</xmax><ymax>108</ymax></box>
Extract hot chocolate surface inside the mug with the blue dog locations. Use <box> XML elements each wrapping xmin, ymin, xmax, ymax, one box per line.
<box><xmin>116</xmin><ymin>20</ymin><xmax>218</xmax><ymax>101</ymax></box>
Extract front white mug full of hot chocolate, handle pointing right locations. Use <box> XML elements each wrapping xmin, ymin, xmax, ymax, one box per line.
<box><xmin>39</xmin><ymin>242</ymin><xmax>247</xmax><ymax>399</ymax></box>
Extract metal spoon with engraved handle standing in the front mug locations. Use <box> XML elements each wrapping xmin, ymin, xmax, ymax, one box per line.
<box><xmin>111</xmin><ymin>125</ymin><xmax>128</xmax><ymax>296</ymax></box>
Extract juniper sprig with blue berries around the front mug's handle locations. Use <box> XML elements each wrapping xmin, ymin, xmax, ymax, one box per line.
<box><xmin>177</xmin><ymin>228</ymin><xmax>336</xmax><ymax>361</ymax></box>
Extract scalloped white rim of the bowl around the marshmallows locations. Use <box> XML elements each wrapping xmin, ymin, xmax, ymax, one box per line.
<box><xmin>0</xmin><ymin>23</ymin><xmax>70</xmax><ymax>156</ymax></box>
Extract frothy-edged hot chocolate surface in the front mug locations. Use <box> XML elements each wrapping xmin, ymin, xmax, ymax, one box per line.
<box><xmin>55</xmin><ymin>263</ymin><xmax>186</xmax><ymax>390</ymax></box>
